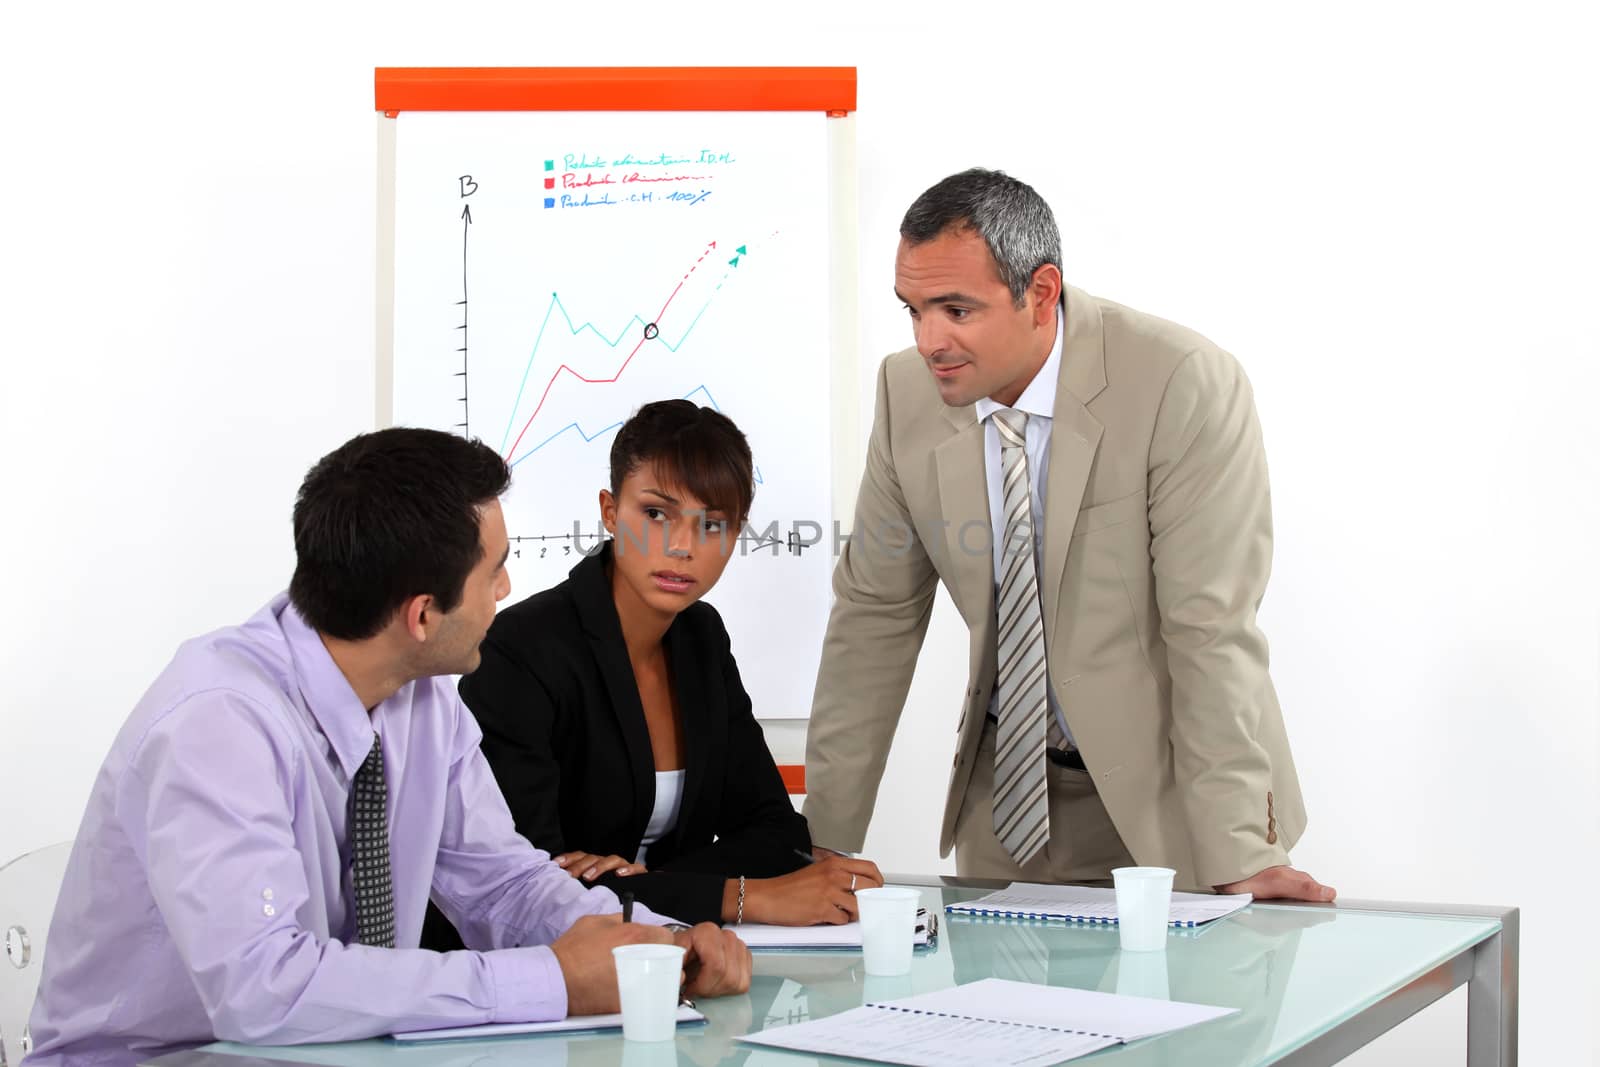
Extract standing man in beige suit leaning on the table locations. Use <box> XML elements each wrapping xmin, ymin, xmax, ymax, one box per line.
<box><xmin>805</xmin><ymin>170</ymin><xmax>1333</xmax><ymax>901</ymax></box>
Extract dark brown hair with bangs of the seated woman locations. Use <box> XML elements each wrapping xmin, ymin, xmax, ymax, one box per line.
<box><xmin>611</xmin><ymin>400</ymin><xmax>755</xmax><ymax>523</ymax></box>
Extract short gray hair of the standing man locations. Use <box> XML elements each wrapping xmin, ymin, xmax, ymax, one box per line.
<box><xmin>901</xmin><ymin>166</ymin><xmax>1061</xmax><ymax>307</ymax></box>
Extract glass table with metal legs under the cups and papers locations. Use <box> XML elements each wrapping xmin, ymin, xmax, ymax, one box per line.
<box><xmin>149</xmin><ymin>875</ymin><xmax>1518</xmax><ymax>1067</ymax></box>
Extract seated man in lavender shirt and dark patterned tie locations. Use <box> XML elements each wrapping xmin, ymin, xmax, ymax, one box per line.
<box><xmin>27</xmin><ymin>429</ymin><xmax>750</xmax><ymax>1065</ymax></box>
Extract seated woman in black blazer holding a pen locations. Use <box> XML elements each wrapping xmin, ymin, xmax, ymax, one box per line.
<box><xmin>432</xmin><ymin>400</ymin><xmax>883</xmax><ymax>925</ymax></box>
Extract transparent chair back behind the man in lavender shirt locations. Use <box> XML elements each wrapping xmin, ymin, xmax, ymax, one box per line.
<box><xmin>0</xmin><ymin>841</ymin><xmax>72</xmax><ymax>1067</ymax></box>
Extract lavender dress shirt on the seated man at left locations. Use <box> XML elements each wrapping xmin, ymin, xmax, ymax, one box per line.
<box><xmin>27</xmin><ymin>595</ymin><xmax>666</xmax><ymax>1065</ymax></box>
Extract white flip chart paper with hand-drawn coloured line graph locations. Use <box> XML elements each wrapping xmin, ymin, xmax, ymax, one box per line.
<box><xmin>390</xmin><ymin>112</ymin><xmax>842</xmax><ymax>717</ymax></box>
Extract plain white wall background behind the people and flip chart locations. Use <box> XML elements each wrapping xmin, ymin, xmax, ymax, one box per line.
<box><xmin>0</xmin><ymin>2</ymin><xmax>1600</xmax><ymax>1065</ymax></box>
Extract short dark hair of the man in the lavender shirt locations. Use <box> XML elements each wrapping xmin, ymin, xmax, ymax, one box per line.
<box><xmin>290</xmin><ymin>427</ymin><xmax>510</xmax><ymax>641</ymax></box>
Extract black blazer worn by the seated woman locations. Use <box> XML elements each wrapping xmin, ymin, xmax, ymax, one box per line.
<box><xmin>428</xmin><ymin>545</ymin><xmax>811</xmax><ymax>940</ymax></box>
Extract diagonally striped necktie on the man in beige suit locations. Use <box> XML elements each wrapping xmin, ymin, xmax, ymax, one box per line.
<box><xmin>992</xmin><ymin>410</ymin><xmax>1050</xmax><ymax>865</ymax></box>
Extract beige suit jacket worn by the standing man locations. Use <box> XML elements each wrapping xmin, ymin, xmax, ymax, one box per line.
<box><xmin>805</xmin><ymin>286</ymin><xmax>1306</xmax><ymax>888</ymax></box>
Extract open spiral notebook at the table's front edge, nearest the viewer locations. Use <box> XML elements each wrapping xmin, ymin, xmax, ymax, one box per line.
<box><xmin>738</xmin><ymin>977</ymin><xmax>1237</xmax><ymax>1067</ymax></box>
